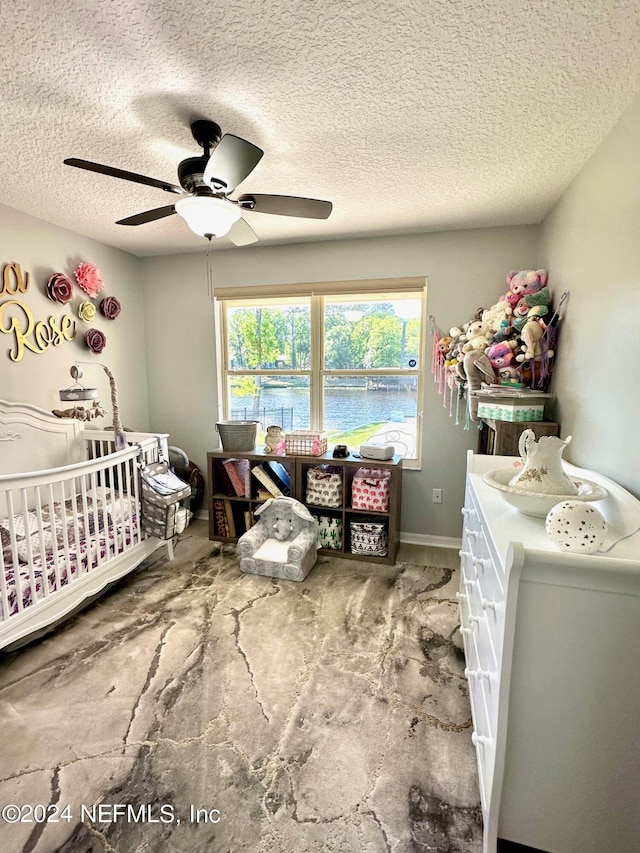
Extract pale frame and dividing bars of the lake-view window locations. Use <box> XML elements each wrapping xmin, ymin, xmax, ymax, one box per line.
<box><xmin>214</xmin><ymin>277</ymin><xmax>427</xmax><ymax>470</ymax></box>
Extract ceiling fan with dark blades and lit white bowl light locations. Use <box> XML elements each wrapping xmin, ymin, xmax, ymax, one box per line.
<box><xmin>64</xmin><ymin>119</ymin><xmax>332</xmax><ymax>246</ymax></box>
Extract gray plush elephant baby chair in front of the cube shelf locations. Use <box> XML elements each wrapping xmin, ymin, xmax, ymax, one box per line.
<box><xmin>238</xmin><ymin>497</ymin><xmax>320</xmax><ymax>581</ymax></box>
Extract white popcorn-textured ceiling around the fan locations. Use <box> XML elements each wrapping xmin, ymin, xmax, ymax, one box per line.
<box><xmin>0</xmin><ymin>0</ymin><xmax>640</xmax><ymax>256</ymax></box>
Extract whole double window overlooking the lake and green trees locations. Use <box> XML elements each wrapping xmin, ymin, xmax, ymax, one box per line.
<box><xmin>216</xmin><ymin>279</ymin><xmax>425</xmax><ymax>467</ymax></box>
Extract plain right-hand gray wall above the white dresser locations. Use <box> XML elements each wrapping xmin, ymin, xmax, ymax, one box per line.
<box><xmin>539</xmin><ymin>90</ymin><xmax>640</xmax><ymax>497</ymax></box>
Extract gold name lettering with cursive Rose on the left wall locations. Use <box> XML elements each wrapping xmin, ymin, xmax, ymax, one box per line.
<box><xmin>0</xmin><ymin>264</ymin><xmax>76</xmax><ymax>361</ymax></box>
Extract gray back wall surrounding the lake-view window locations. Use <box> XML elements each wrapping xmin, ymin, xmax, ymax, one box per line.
<box><xmin>143</xmin><ymin>226</ymin><xmax>538</xmax><ymax>537</ymax></box>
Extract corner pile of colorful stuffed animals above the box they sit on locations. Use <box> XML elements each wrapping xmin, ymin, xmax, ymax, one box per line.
<box><xmin>429</xmin><ymin>270</ymin><xmax>568</xmax><ymax>429</ymax></box>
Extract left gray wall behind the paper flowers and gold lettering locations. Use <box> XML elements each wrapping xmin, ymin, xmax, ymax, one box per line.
<box><xmin>0</xmin><ymin>206</ymin><xmax>149</xmax><ymax>432</ymax></box>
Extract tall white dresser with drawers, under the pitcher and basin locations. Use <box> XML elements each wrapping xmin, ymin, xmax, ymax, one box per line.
<box><xmin>458</xmin><ymin>452</ymin><xmax>640</xmax><ymax>853</ymax></box>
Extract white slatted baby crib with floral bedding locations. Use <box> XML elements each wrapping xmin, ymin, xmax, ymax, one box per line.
<box><xmin>0</xmin><ymin>401</ymin><xmax>173</xmax><ymax>651</ymax></box>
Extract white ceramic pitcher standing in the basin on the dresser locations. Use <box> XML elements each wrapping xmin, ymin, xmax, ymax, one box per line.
<box><xmin>509</xmin><ymin>429</ymin><xmax>578</xmax><ymax>497</ymax></box>
